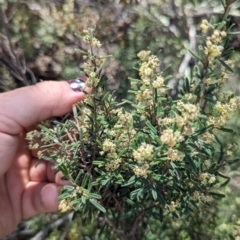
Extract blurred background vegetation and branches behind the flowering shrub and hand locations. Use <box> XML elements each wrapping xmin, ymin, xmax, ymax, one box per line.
<box><xmin>0</xmin><ymin>0</ymin><xmax>240</xmax><ymax>240</ymax></box>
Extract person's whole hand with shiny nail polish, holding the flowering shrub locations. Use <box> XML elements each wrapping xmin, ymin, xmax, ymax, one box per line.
<box><xmin>0</xmin><ymin>81</ymin><xmax>88</xmax><ymax>238</ymax></box>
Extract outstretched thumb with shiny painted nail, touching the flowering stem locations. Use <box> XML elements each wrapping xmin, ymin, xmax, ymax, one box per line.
<box><xmin>0</xmin><ymin>81</ymin><xmax>90</xmax><ymax>135</ymax></box>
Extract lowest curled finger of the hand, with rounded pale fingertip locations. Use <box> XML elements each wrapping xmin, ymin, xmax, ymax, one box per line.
<box><xmin>22</xmin><ymin>182</ymin><xmax>59</xmax><ymax>218</ymax></box>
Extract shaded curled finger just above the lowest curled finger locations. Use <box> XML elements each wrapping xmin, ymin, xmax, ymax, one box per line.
<box><xmin>29</xmin><ymin>159</ymin><xmax>71</xmax><ymax>185</ymax></box>
